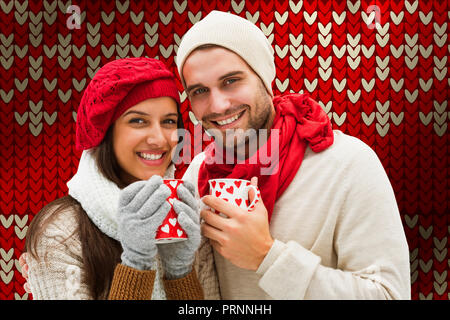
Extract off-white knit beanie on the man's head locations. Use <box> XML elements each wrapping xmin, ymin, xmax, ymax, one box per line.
<box><xmin>176</xmin><ymin>10</ymin><xmax>275</xmax><ymax>96</ymax></box>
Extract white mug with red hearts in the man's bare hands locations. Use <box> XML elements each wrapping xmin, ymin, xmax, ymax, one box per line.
<box><xmin>208</xmin><ymin>179</ymin><xmax>261</xmax><ymax>212</ymax></box>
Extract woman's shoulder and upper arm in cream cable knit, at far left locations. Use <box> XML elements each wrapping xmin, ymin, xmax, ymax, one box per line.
<box><xmin>26</xmin><ymin>197</ymin><xmax>90</xmax><ymax>300</ymax></box>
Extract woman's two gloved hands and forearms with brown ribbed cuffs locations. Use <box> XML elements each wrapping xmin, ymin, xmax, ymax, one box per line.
<box><xmin>109</xmin><ymin>176</ymin><xmax>203</xmax><ymax>300</ymax></box>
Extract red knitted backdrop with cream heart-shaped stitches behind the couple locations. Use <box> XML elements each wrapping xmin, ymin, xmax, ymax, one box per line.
<box><xmin>0</xmin><ymin>0</ymin><xmax>450</xmax><ymax>299</ymax></box>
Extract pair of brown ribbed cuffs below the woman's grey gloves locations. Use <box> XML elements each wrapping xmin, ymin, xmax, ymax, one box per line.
<box><xmin>108</xmin><ymin>264</ymin><xmax>204</xmax><ymax>300</ymax></box>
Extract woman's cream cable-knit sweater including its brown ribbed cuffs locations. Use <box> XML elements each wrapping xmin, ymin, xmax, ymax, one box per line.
<box><xmin>27</xmin><ymin>208</ymin><xmax>220</xmax><ymax>300</ymax></box>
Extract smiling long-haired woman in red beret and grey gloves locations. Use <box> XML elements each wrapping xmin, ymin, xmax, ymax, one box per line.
<box><xmin>21</xmin><ymin>58</ymin><xmax>218</xmax><ymax>299</ymax></box>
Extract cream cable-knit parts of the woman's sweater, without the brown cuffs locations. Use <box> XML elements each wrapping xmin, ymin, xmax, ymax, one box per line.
<box><xmin>27</xmin><ymin>209</ymin><xmax>220</xmax><ymax>300</ymax></box>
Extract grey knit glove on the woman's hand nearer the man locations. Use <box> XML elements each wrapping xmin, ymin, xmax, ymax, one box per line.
<box><xmin>158</xmin><ymin>181</ymin><xmax>201</xmax><ymax>279</ymax></box>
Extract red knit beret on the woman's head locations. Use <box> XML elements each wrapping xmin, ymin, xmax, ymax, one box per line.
<box><xmin>75</xmin><ymin>58</ymin><xmax>180</xmax><ymax>150</ymax></box>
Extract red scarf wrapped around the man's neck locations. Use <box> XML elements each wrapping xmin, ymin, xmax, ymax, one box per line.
<box><xmin>198</xmin><ymin>94</ymin><xmax>333</xmax><ymax>221</ymax></box>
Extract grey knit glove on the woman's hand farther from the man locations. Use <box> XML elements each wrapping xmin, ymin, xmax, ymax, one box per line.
<box><xmin>117</xmin><ymin>175</ymin><xmax>171</xmax><ymax>270</ymax></box>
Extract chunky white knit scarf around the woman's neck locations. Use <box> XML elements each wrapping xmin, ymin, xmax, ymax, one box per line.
<box><xmin>67</xmin><ymin>150</ymin><xmax>175</xmax><ymax>241</ymax></box>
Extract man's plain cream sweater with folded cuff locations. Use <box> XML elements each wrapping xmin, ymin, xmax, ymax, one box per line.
<box><xmin>183</xmin><ymin>131</ymin><xmax>411</xmax><ymax>299</ymax></box>
